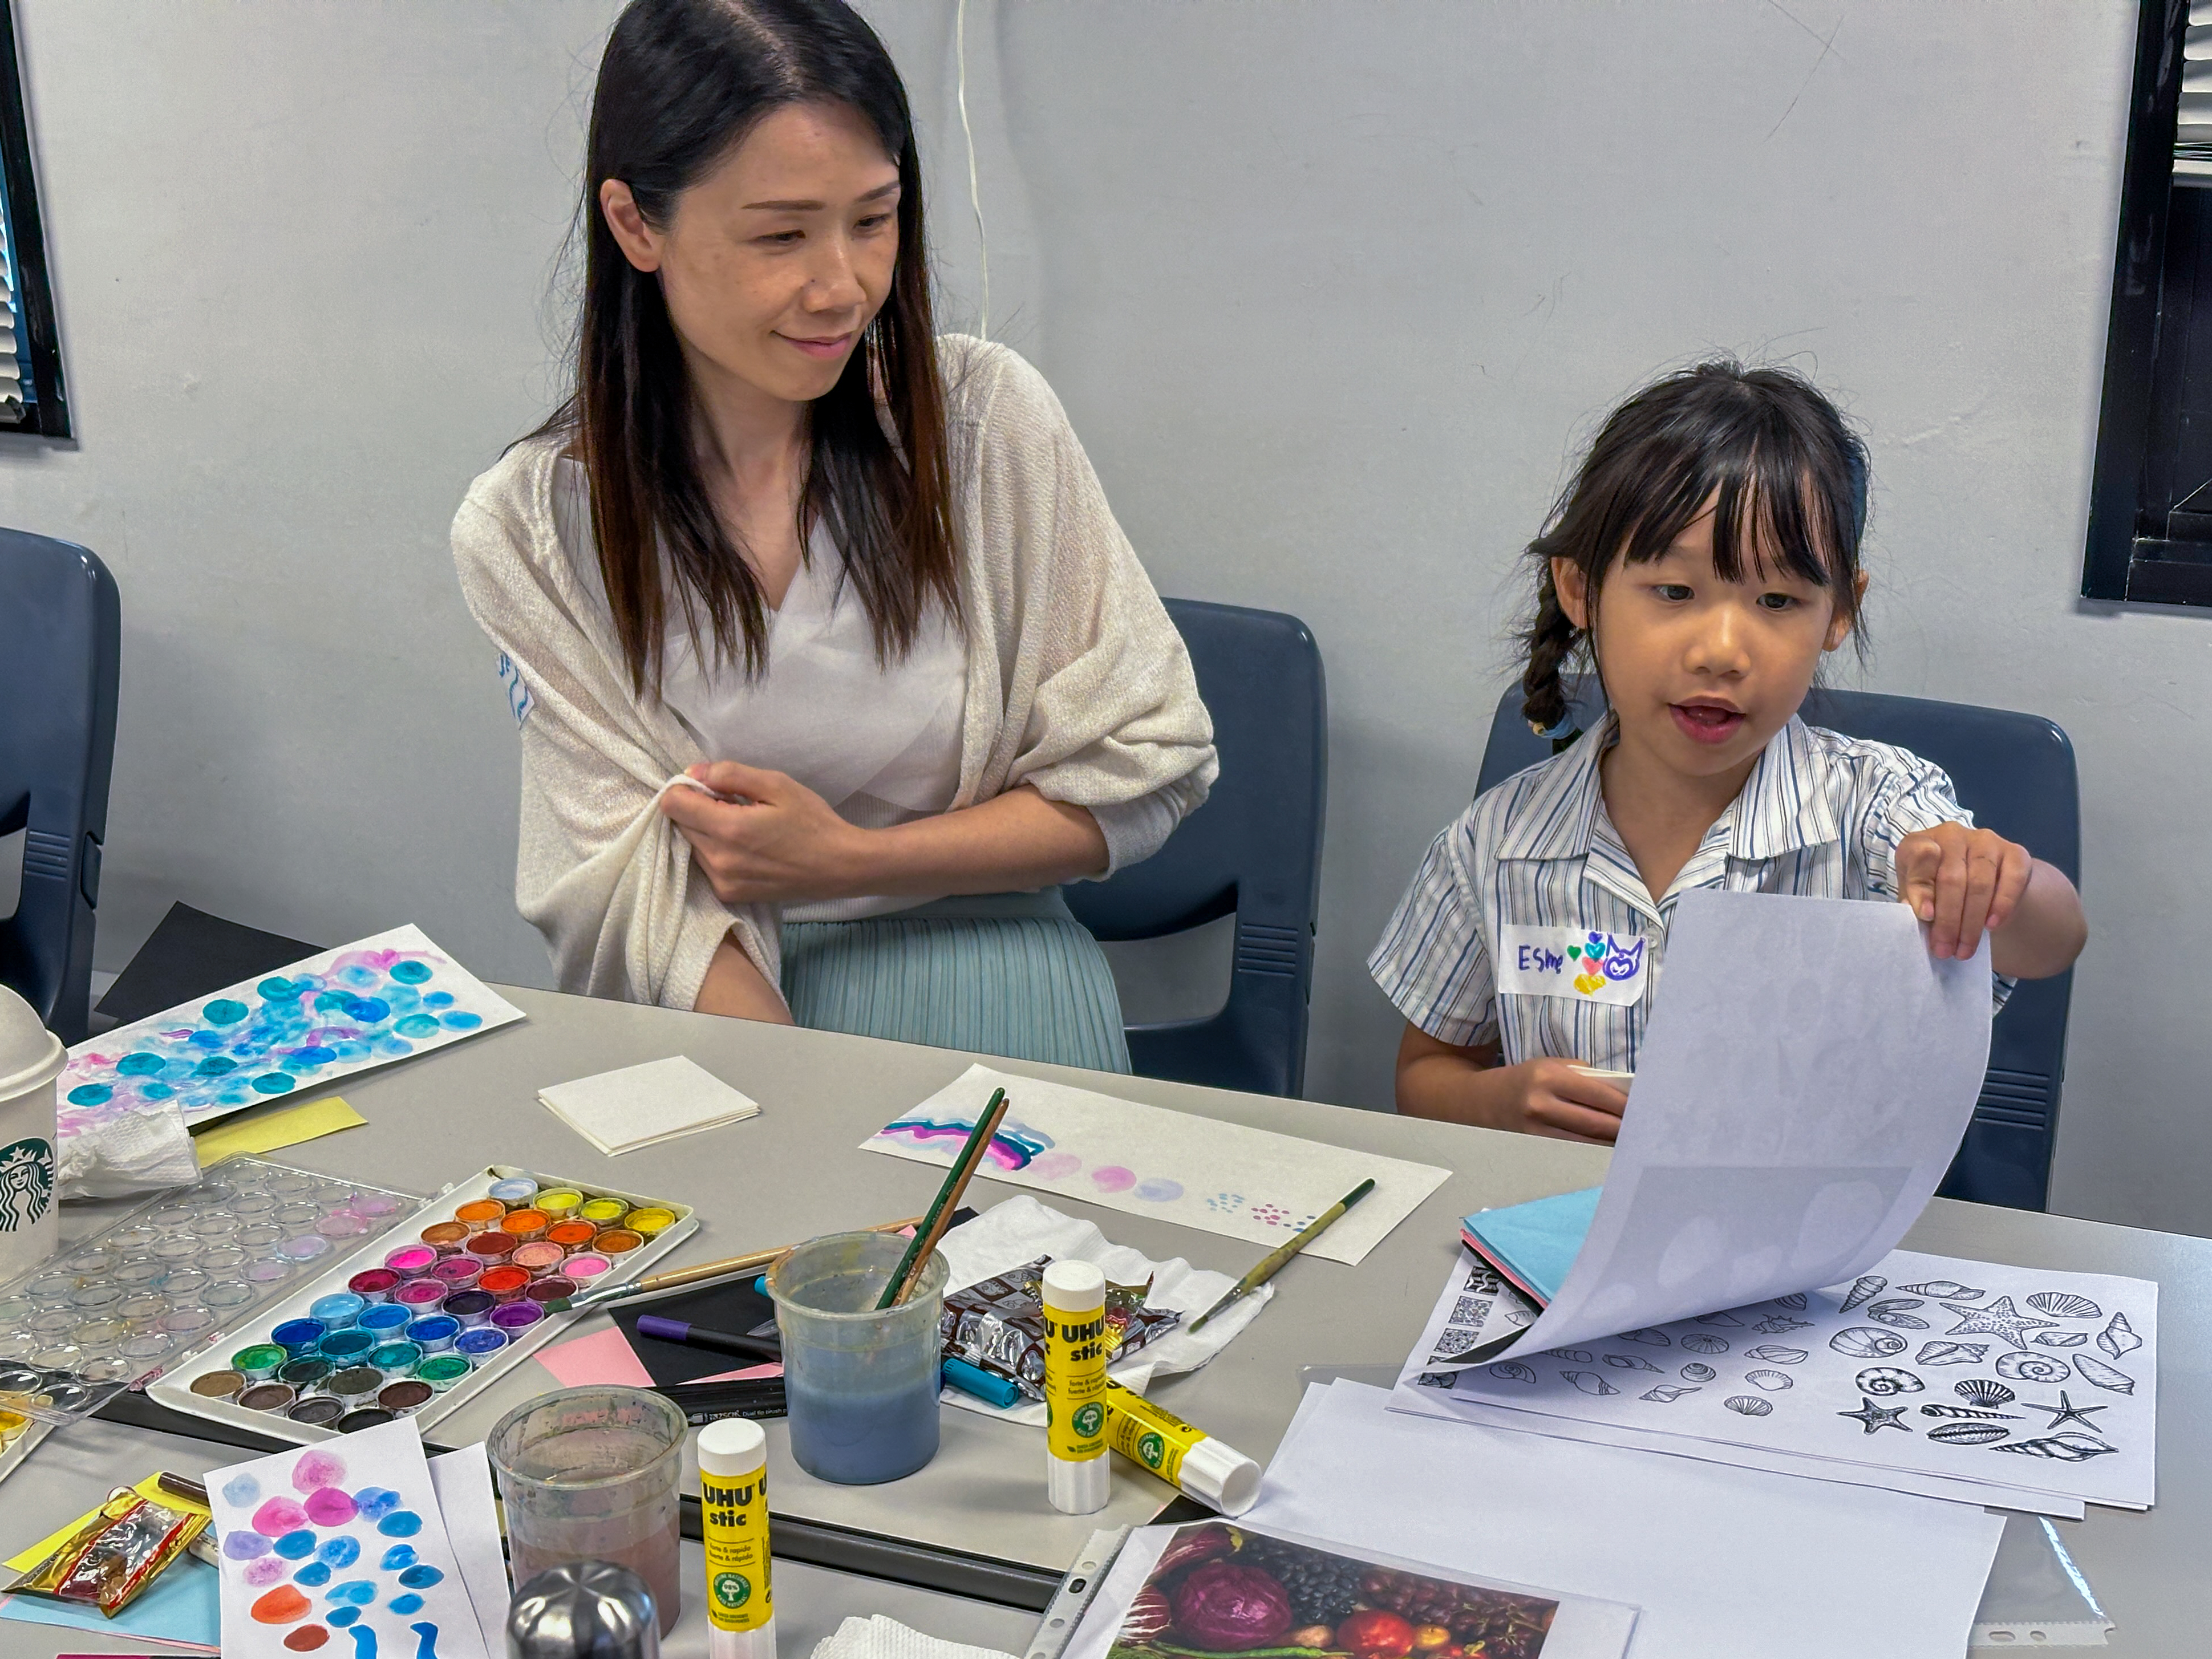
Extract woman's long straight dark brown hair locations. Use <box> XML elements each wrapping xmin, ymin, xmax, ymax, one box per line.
<box><xmin>533</xmin><ymin>0</ymin><xmax>960</xmax><ymax>692</ymax></box>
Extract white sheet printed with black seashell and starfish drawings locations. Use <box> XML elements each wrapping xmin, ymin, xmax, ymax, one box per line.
<box><xmin>1396</xmin><ymin>1250</ymin><xmax>2159</xmax><ymax>1513</ymax></box>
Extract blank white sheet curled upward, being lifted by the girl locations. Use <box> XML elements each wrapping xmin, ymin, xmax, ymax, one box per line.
<box><xmin>1504</xmin><ymin>889</ymin><xmax>1991</xmax><ymax>1356</ymax></box>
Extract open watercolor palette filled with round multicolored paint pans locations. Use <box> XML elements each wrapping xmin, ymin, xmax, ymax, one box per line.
<box><xmin>146</xmin><ymin>1163</ymin><xmax>699</xmax><ymax>1445</ymax></box>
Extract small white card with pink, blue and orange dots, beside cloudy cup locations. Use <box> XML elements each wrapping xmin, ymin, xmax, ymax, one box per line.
<box><xmin>208</xmin><ymin>1418</ymin><xmax>489</xmax><ymax>1659</ymax></box>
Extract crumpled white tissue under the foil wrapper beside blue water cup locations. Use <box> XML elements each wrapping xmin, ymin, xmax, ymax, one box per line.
<box><xmin>938</xmin><ymin>1192</ymin><xmax>1274</xmax><ymax>1429</ymax></box>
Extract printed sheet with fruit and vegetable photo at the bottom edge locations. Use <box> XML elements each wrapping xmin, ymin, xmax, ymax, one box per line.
<box><xmin>1062</xmin><ymin>1518</ymin><xmax>1637</xmax><ymax>1659</ymax></box>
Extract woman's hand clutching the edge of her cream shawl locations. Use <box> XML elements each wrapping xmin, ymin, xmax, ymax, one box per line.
<box><xmin>659</xmin><ymin>761</ymin><xmax>872</xmax><ymax>904</ymax></box>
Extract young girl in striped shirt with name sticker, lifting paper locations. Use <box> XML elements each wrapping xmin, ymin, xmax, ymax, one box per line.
<box><xmin>1367</xmin><ymin>363</ymin><xmax>2086</xmax><ymax>1141</ymax></box>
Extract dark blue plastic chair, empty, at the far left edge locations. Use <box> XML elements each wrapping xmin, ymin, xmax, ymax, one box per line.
<box><xmin>0</xmin><ymin>531</ymin><xmax>121</xmax><ymax>1042</ymax></box>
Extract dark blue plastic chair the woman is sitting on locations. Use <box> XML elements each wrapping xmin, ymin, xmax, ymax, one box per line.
<box><xmin>1062</xmin><ymin>599</ymin><xmax>1330</xmax><ymax>1095</ymax></box>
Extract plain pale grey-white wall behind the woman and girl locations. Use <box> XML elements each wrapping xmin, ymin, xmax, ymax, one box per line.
<box><xmin>0</xmin><ymin>0</ymin><xmax>2212</xmax><ymax>1232</ymax></box>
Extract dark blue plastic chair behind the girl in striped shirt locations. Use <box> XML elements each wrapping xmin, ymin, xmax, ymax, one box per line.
<box><xmin>1476</xmin><ymin>677</ymin><xmax>2081</xmax><ymax>1210</ymax></box>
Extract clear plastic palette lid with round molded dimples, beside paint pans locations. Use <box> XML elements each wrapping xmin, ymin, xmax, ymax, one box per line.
<box><xmin>0</xmin><ymin>1155</ymin><xmax>423</xmax><ymax>1453</ymax></box>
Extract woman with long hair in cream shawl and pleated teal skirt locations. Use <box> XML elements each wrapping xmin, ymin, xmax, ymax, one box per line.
<box><xmin>453</xmin><ymin>0</ymin><xmax>1217</xmax><ymax>1070</ymax></box>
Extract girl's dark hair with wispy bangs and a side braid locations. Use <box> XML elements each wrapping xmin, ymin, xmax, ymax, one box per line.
<box><xmin>1522</xmin><ymin>360</ymin><xmax>1867</xmax><ymax>732</ymax></box>
